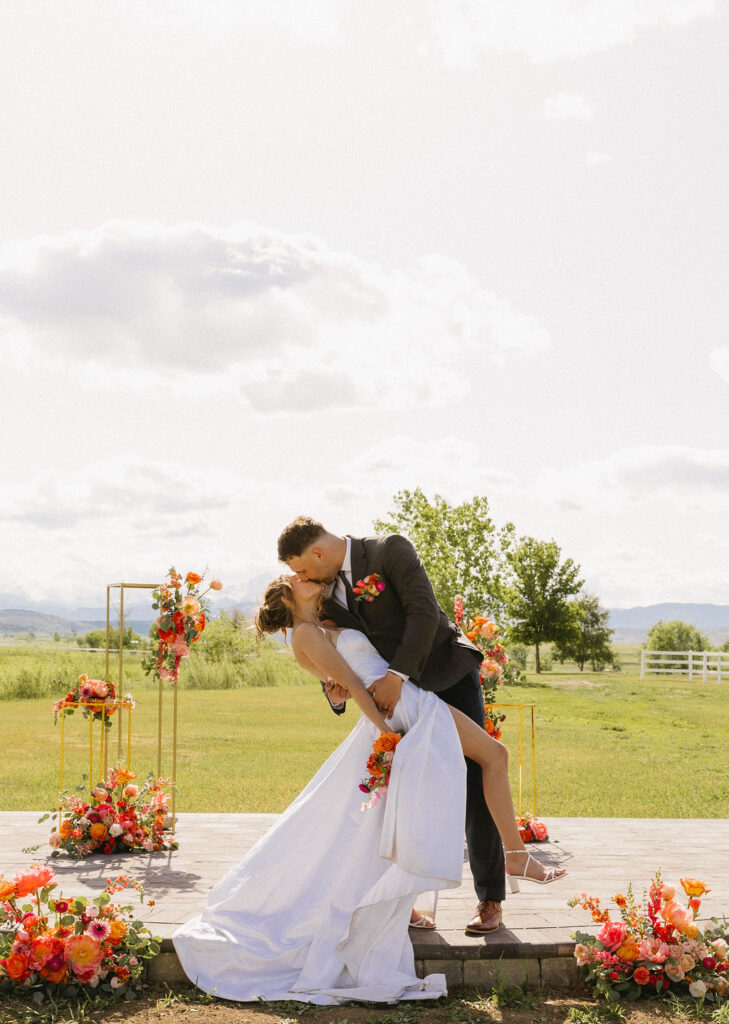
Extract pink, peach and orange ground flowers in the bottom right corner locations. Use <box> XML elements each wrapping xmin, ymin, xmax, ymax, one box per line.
<box><xmin>568</xmin><ymin>872</ymin><xmax>729</xmax><ymax>1002</ymax></box>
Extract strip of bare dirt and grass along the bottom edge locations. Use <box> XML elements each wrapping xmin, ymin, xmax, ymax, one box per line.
<box><xmin>0</xmin><ymin>989</ymin><xmax>711</xmax><ymax>1024</ymax></box>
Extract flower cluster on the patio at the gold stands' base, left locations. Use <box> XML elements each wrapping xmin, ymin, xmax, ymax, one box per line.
<box><xmin>39</xmin><ymin>767</ymin><xmax>178</xmax><ymax>857</ymax></box>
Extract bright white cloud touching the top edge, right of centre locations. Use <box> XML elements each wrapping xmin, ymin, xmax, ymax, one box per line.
<box><xmin>423</xmin><ymin>0</ymin><xmax>716</xmax><ymax>68</ymax></box>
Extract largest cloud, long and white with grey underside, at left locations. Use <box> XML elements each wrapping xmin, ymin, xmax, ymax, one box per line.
<box><xmin>0</xmin><ymin>222</ymin><xmax>549</xmax><ymax>411</ymax></box>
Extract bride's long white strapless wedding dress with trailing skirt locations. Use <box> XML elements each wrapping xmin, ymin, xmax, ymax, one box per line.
<box><xmin>172</xmin><ymin>630</ymin><xmax>466</xmax><ymax>1005</ymax></box>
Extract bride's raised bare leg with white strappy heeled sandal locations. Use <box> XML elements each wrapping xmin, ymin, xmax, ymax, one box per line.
<box><xmin>449</xmin><ymin>708</ymin><xmax>565</xmax><ymax>881</ymax></box>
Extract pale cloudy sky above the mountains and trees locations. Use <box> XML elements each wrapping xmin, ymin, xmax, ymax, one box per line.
<box><xmin>0</xmin><ymin>0</ymin><xmax>729</xmax><ymax>607</ymax></box>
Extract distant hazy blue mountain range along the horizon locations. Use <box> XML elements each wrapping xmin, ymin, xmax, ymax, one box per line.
<box><xmin>0</xmin><ymin>593</ymin><xmax>729</xmax><ymax>644</ymax></box>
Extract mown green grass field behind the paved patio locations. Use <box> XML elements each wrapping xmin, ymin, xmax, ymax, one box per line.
<box><xmin>0</xmin><ymin>652</ymin><xmax>729</xmax><ymax>818</ymax></box>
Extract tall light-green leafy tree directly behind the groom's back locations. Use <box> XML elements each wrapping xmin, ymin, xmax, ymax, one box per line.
<box><xmin>373</xmin><ymin>487</ymin><xmax>514</xmax><ymax>620</ymax></box>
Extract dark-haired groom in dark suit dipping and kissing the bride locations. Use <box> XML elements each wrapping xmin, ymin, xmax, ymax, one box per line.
<box><xmin>278</xmin><ymin>516</ymin><xmax>505</xmax><ymax>935</ymax></box>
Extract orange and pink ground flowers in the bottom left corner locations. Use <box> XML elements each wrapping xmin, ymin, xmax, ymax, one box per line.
<box><xmin>0</xmin><ymin>864</ymin><xmax>161</xmax><ymax>1002</ymax></box>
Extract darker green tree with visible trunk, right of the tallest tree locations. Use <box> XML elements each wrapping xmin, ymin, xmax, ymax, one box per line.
<box><xmin>506</xmin><ymin>537</ymin><xmax>583</xmax><ymax>673</ymax></box>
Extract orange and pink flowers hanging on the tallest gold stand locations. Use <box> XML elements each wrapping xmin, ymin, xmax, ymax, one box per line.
<box><xmin>141</xmin><ymin>566</ymin><xmax>223</xmax><ymax>686</ymax></box>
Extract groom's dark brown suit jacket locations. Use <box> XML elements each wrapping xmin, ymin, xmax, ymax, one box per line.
<box><xmin>323</xmin><ymin>534</ymin><xmax>483</xmax><ymax>693</ymax></box>
